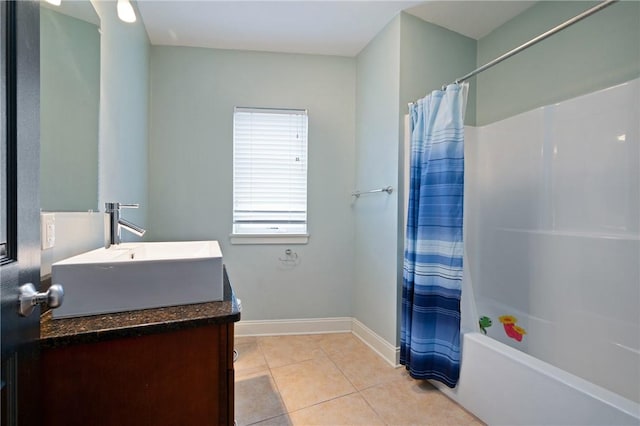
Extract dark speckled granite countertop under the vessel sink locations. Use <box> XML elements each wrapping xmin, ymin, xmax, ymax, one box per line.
<box><xmin>40</xmin><ymin>270</ymin><xmax>240</xmax><ymax>348</ymax></box>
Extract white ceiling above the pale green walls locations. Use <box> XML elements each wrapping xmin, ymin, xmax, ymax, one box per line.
<box><xmin>137</xmin><ymin>0</ymin><xmax>535</xmax><ymax>56</ymax></box>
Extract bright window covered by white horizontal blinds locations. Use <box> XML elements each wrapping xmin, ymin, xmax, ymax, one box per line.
<box><xmin>232</xmin><ymin>107</ymin><xmax>308</xmax><ymax>243</ymax></box>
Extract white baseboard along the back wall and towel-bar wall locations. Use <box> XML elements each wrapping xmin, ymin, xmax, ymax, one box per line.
<box><xmin>234</xmin><ymin>317</ymin><xmax>400</xmax><ymax>367</ymax></box>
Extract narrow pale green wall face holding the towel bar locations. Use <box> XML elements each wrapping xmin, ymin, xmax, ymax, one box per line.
<box><xmin>353</xmin><ymin>16</ymin><xmax>400</xmax><ymax>346</ymax></box>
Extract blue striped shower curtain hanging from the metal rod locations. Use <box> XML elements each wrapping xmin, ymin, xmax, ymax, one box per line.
<box><xmin>400</xmin><ymin>83</ymin><xmax>468</xmax><ymax>387</ymax></box>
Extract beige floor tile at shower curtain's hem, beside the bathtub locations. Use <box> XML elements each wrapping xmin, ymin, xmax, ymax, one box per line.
<box><xmin>361</xmin><ymin>378</ymin><xmax>462</xmax><ymax>425</ymax></box>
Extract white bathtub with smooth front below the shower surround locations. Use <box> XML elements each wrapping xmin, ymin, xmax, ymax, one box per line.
<box><xmin>433</xmin><ymin>332</ymin><xmax>640</xmax><ymax>426</ymax></box>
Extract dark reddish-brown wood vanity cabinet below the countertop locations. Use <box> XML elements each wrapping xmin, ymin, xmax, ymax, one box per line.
<box><xmin>39</xmin><ymin>322</ymin><xmax>234</xmax><ymax>426</ymax></box>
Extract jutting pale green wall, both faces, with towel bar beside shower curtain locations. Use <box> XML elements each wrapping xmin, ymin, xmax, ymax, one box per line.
<box><xmin>353</xmin><ymin>13</ymin><xmax>476</xmax><ymax>346</ymax></box>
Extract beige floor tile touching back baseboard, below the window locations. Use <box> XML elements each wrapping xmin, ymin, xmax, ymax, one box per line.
<box><xmin>258</xmin><ymin>335</ymin><xmax>324</xmax><ymax>368</ymax></box>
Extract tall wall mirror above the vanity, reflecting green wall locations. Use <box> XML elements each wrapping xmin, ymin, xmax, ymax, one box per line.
<box><xmin>40</xmin><ymin>0</ymin><xmax>100</xmax><ymax>211</ymax></box>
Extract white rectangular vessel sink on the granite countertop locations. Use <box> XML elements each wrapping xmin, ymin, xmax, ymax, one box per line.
<box><xmin>51</xmin><ymin>241</ymin><xmax>223</xmax><ymax>318</ymax></box>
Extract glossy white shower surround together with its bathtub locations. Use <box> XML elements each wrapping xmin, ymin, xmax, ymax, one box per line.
<box><xmin>436</xmin><ymin>80</ymin><xmax>640</xmax><ymax>425</ymax></box>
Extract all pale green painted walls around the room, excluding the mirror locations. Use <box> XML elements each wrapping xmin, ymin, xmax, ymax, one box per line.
<box><xmin>52</xmin><ymin>1</ymin><xmax>640</xmax><ymax>352</ymax></box>
